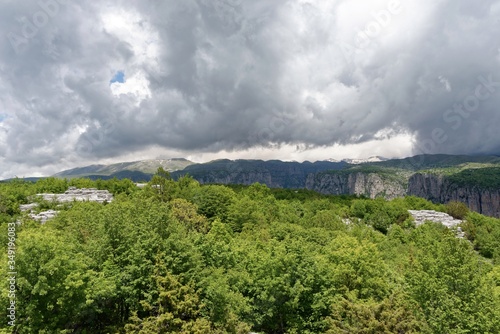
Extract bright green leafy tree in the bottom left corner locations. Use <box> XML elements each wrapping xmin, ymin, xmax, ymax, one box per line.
<box><xmin>11</xmin><ymin>229</ymin><xmax>91</xmax><ymax>333</ymax></box>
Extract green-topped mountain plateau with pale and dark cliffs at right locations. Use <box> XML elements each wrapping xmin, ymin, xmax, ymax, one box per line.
<box><xmin>305</xmin><ymin>154</ymin><xmax>500</xmax><ymax>218</ymax></box>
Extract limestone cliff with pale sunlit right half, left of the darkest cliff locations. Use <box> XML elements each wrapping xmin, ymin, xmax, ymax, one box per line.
<box><xmin>306</xmin><ymin>172</ymin><xmax>406</xmax><ymax>199</ymax></box>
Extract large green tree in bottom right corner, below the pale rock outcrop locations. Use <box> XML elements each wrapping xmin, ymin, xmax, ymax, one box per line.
<box><xmin>404</xmin><ymin>223</ymin><xmax>500</xmax><ymax>333</ymax></box>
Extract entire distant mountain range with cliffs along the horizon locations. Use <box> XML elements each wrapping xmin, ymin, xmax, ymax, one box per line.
<box><xmin>7</xmin><ymin>154</ymin><xmax>500</xmax><ymax>217</ymax></box>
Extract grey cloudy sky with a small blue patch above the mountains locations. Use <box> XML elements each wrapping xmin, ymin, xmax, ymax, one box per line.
<box><xmin>0</xmin><ymin>0</ymin><xmax>500</xmax><ymax>179</ymax></box>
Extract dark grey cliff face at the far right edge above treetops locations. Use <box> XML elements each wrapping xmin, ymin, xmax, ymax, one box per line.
<box><xmin>408</xmin><ymin>173</ymin><xmax>500</xmax><ymax>218</ymax></box>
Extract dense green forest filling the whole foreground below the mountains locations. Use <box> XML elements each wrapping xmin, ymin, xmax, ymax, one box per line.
<box><xmin>0</xmin><ymin>170</ymin><xmax>500</xmax><ymax>333</ymax></box>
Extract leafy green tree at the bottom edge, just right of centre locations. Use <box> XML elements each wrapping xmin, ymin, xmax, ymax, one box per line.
<box><xmin>242</xmin><ymin>235</ymin><xmax>333</xmax><ymax>333</ymax></box>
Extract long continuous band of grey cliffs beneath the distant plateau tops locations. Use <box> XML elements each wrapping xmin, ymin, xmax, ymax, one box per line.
<box><xmin>172</xmin><ymin>158</ymin><xmax>500</xmax><ymax>218</ymax></box>
